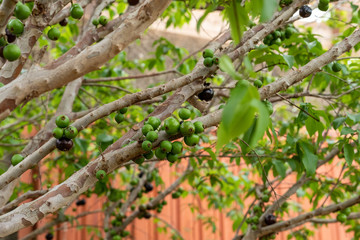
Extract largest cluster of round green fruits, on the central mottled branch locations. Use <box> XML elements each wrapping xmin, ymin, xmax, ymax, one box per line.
<box><xmin>138</xmin><ymin>108</ymin><xmax>204</xmax><ymax>164</ymax></box>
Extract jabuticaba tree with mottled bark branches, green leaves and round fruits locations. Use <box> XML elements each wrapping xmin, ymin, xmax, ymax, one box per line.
<box><xmin>0</xmin><ymin>0</ymin><xmax>360</xmax><ymax>240</ymax></box>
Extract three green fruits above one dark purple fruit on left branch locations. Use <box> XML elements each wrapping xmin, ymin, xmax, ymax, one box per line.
<box><xmin>53</xmin><ymin>115</ymin><xmax>78</xmax><ymax>151</ymax></box>
